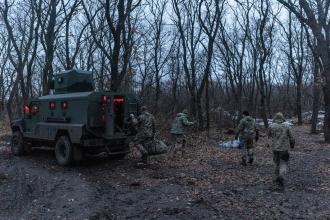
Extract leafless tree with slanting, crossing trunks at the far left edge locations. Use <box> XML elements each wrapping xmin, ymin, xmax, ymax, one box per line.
<box><xmin>1</xmin><ymin>0</ymin><xmax>39</xmax><ymax>119</ymax></box>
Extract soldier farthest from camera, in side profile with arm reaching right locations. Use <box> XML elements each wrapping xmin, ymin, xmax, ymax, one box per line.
<box><xmin>171</xmin><ymin>109</ymin><xmax>195</xmax><ymax>158</ymax></box>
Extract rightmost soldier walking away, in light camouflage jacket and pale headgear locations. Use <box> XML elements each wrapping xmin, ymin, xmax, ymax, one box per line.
<box><xmin>268</xmin><ymin>112</ymin><xmax>295</xmax><ymax>187</ymax></box>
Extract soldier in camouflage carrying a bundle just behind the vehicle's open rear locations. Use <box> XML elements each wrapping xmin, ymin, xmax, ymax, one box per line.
<box><xmin>133</xmin><ymin>106</ymin><xmax>155</xmax><ymax>163</ymax></box>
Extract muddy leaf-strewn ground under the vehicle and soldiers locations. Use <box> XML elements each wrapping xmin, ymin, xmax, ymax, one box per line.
<box><xmin>0</xmin><ymin>126</ymin><xmax>330</xmax><ymax>220</ymax></box>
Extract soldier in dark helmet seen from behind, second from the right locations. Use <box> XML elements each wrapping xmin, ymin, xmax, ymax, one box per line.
<box><xmin>235</xmin><ymin>111</ymin><xmax>259</xmax><ymax>166</ymax></box>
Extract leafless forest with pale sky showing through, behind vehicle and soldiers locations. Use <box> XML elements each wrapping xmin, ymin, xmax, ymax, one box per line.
<box><xmin>0</xmin><ymin>0</ymin><xmax>330</xmax><ymax>134</ymax></box>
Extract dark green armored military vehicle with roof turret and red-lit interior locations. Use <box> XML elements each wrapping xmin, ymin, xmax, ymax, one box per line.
<box><xmin>11</xmin><ymin>70</ymin><xmax>138</xmax><ymax>165</ymax></box>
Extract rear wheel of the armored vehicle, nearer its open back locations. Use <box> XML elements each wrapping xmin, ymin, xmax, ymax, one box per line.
<box><xmin>55</xmin><ymin>136</ymin><xmax>73</xmax><ymax>166</ymax></box>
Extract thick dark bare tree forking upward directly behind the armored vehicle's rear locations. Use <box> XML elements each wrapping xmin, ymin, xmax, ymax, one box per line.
<box><xmin>82</xmin><ymin>0</ymin><xmax>141</xmax><ymax>91</ymax></box>
